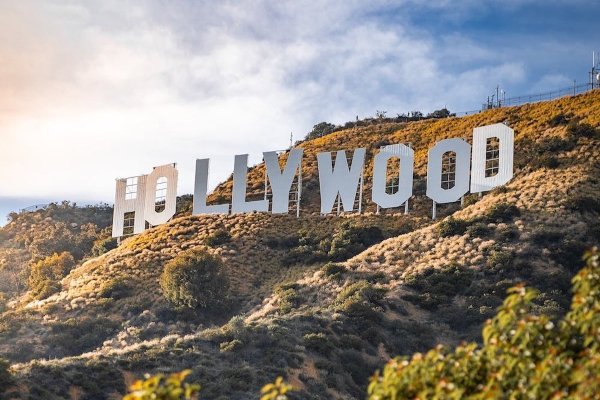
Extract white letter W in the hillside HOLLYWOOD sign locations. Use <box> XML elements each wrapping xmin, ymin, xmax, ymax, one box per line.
<box><xmin>317</xmin><ymin>148</ymin><xmax>366</xmax><ymax>214</ymax></box>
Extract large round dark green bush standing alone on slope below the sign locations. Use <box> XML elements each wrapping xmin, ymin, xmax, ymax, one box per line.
<box><xmin>160</xmin><ymin>250</ymin><xmax>229</xmax><ymax>309</ymax></box>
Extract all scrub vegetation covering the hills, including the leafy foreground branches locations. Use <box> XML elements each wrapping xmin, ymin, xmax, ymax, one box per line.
<box><xmin>0</xmin><ymin>91</ymin><xmax>600</xmax><ymax>399</ymax></box>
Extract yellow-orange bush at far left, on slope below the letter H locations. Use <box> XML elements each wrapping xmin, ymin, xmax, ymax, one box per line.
<box><xmin>29</xmin><ymin>251</ymin><xmax>75</xmax><ymax>299</ymax></box>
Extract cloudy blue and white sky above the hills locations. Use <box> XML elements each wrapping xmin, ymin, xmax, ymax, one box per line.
<box><xmin>0</xmin><ymin>0</ymin><xmax>600</xmax><ymax>224</ymax></box>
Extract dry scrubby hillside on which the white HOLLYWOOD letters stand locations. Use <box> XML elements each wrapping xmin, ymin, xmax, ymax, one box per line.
<box><xmin>0</xmin><ymin>90</ymin><xmax>600</xmax><ymax>399</ymax></box>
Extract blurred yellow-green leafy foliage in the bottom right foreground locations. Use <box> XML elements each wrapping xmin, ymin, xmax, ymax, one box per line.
<box><xmin>368</xmin><ymin>249</ymin><xmax>600</xmax><ymax>400</ymax></box>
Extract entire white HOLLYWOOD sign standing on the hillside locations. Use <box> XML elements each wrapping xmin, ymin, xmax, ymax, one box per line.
<box><xmin>112</xmin><ymin>124</ymin><xmax>514</xmax><ymax>237</ymax></box>
